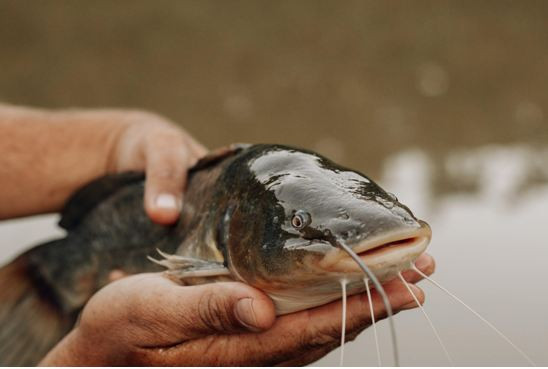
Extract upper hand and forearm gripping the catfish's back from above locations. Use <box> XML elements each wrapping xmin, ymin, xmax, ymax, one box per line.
<box><xmin>0</xmin><ymin>104</ymin><xmax>206</xmax><ymax>224</ymax></box>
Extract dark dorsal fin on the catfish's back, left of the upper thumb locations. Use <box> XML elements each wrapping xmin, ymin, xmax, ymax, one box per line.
<box><xmin>59</xmin><ymin>172</ymin><xmax>145</xmax><ymax>230</ymax></box>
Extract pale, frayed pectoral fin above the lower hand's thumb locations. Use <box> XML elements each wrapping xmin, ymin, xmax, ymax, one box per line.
<box><xmin>148</xmin><ymin>250</ymin><xmax>230</xmax><ymax>280</ymax></box>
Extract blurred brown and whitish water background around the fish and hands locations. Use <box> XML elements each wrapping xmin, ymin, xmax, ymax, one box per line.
<box><xmin>0</xmin><ymin>0</ymin><xmax>548</xmax><ymax>366</ymax></box>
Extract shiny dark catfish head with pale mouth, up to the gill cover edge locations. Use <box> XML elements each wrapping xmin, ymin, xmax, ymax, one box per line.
<box><xmin>220</xmin><ymin>145</ymin><xmax>431</xmax><ymax>312</ymax></box>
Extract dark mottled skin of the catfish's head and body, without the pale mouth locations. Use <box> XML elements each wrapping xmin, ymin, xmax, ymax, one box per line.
<box><xmin>0</xmin><ymin>145</ymin><xmax>422</xmax><ymax>365</ymax></box>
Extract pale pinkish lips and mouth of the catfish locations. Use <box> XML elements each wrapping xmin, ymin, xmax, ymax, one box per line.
<box><xmin>320</xmin><ymin>221</ymin><xmax>432</xmax><ymax>280</ymax></box>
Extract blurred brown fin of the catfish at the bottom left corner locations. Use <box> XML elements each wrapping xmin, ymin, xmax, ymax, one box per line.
<box><xmin>0</xmin><ymin>254</ymin><xmax>76</xmax><ymax>366</ymax></box>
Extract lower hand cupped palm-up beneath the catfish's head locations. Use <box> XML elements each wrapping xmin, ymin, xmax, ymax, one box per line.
<box><xmin>42</xmin><ymin>255</ymin><xmax>434</xmax><ymax>366</ymax></box>
